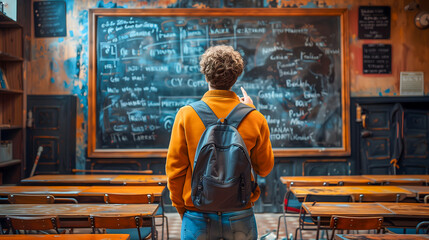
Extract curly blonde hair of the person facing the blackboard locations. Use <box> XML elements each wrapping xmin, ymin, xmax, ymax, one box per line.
<box><xmin>200</xmin><ymin>45</ymin><xmax>244</xmax><ymax>90</ymax></box>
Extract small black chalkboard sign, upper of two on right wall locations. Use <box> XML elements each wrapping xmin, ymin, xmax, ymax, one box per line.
<box><xmin>358</xmin><ymin>6</ymin><xmax>390</xmax><ymax>39</ymax></box>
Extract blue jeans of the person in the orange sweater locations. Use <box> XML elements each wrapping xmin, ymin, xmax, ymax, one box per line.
<box><xmin>180</xmin><ymin>208</ymin><xmax>258</xmax><ymax>240</ymax></box>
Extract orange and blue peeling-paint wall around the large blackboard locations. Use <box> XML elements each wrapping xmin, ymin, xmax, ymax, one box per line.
<box><xmin>26</xmin><ymin>0</ymin><xmax>429</xmax><ymax>169</ymax></box>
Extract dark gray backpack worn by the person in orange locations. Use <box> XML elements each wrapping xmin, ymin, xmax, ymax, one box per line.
<box><xmin>190</xmin><ymin>101</ymin><xmax>256</xmax><ymax>212</ymax></box>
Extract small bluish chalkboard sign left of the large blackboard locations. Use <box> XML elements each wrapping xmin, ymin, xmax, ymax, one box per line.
<box><xmin>33</xmin><ymin>1</ymin><xmax>67</xmax><ymax>37</ymax></box>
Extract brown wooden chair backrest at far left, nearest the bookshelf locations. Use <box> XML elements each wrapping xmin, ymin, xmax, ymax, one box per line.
<box><xmin>8</xmin><ymin>194</ymin><xmax>77</xmax><ymax>204</ymax></box>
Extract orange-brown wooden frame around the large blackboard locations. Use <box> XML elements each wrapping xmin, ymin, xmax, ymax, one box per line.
<box><xmin>88</xmin><ymin>8</ymin><xmax>350</xmax><ymax>158</ymax></box>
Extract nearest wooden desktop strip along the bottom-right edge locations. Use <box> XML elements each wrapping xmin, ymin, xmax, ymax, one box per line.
<box><xmin>334</xmin><ymin>234</ymin><xmax>429</xmax><ymax>240</ymax></box>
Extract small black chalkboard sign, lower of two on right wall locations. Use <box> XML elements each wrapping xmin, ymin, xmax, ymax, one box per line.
<box><xmin>363</xmin><ymin>44</ymin><xmax>392</xmax><ymax>74</ymax></box>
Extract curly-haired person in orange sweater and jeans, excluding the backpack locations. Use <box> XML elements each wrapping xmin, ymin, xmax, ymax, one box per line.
<box><xmin>166</xmin><ymin>45</ymin><xmax>274</xmax><ymax>240</ymax></box>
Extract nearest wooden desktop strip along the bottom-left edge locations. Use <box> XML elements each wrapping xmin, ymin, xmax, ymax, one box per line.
<box><xmin>0</xmin><ymin>234</ymin><xmax>130</xmax><ymax>240</ymax></box>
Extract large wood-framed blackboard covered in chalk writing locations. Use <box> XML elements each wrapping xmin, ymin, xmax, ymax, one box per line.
<box><xmin>88</xmin><ymin>8</ymin><xmax>350</xmax><ymax>158</ymax></box>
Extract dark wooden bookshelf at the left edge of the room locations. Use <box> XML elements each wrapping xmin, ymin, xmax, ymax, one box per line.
<box><xmin>0</xmin><ymin>13</ymin><xmax>25</xmax><ymax>184</ymax></box>
